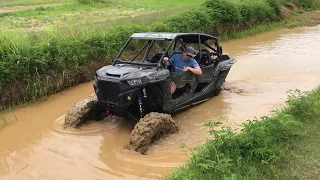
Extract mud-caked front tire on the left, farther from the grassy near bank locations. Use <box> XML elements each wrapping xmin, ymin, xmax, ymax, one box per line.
<box><xmin>64</xmin><ymin>96</ymin><xmax>97</xmax><ymax>127</ymax></box>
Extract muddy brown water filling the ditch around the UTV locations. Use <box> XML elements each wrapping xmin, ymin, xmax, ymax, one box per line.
<box><xmin>0</xmin><ymin>26</ymin><xmax>320</xmax><ymax>180</ymax></box>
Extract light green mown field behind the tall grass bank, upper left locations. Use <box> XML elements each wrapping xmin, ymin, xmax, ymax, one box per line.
<box><xmin>0</xmin><ymin>0</ymin><xmax>205</xmax><ymax>31</ymax></box>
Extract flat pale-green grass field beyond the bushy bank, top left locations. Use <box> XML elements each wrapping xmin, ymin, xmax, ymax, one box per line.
<box><xmin>0</xmin><ymin>0</ymin><xmax>206</xmax><ymax>33</ymax></box>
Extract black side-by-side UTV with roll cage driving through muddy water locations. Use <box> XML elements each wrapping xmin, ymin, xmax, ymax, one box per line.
<box><xmin>66</xmin><ymin>33</ymin><xmax>235</xmax><ymax>153</ymax></box>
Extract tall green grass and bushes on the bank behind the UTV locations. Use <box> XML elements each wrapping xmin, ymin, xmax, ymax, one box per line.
<box><xmin>0</xmin><ymin>0</ymin><xmax>320</xmax><ymax>110</ymax></box>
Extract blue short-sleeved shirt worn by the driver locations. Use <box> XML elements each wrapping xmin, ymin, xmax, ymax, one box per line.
<box><xmin>169</xmin><ymin>54</ymin><xmax>199</xmax><ymax>73</ymax></box>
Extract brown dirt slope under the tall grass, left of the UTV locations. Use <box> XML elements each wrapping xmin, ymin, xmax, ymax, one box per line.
<box><xmin>0</xmin><ymin>61</ymin><xmax>110</xmax><ymax>111</ymax></box>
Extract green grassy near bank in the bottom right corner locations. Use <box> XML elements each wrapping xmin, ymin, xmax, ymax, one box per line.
<box><xmin>166</xmin><ymin>88</ymin><xmax>320</xmax><ymax>179</ymax></box>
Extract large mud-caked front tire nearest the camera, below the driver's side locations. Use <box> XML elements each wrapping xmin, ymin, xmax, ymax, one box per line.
<box><xmin>129</xmin><ymin>112</ymin><xmax>179</xmax><ymax>154</ymax></box>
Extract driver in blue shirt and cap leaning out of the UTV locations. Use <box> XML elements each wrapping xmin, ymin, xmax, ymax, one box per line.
<box><xmin>163</xmin><ymin>46</ymin><xmax>202</xmax><ymax>94</ymax></box>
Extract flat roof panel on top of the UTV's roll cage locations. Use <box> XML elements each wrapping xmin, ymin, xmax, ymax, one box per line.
<box><xmin>131</xmin><ymin>32</ymin><xmax>217</xmax><ymax>40</ymax></box>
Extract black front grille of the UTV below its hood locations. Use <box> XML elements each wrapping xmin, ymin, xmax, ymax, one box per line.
<box><xmin>98</xmin><ymin>81</ymin><xmax>121</xmax><ymax>102</ymax></box>
